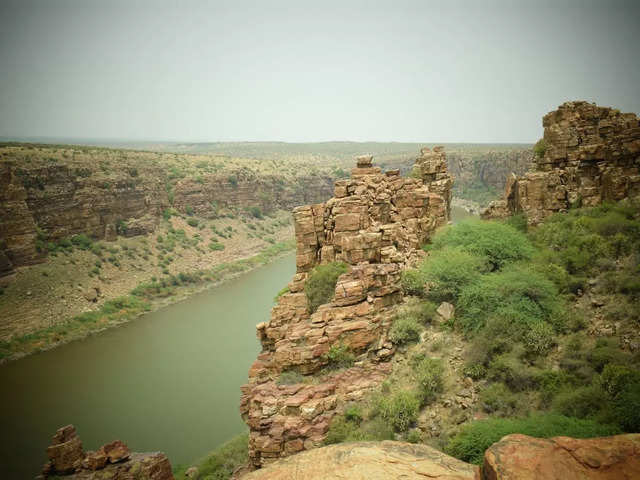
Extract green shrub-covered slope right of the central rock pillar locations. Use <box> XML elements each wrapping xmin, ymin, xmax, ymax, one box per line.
<box><xmin>312</xmin><ymin>204</ymin><xmax>640</xmax><ymax>463</ymax></box>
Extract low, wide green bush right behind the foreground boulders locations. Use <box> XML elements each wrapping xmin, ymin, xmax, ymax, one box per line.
<box><xmin>445</xmin><ymin>414</ymin><xmax>619</xmax><ymax>465</ymax></box>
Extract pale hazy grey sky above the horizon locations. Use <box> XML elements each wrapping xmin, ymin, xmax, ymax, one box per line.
<box><xmin>0</xmin><ymin>0</ymin><xmax>640</xmax><ymax>143</ymax></box>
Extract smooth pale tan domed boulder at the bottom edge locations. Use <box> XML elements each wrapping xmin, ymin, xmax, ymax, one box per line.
<box><xmin>243</xmin><ymin>441</ymin><xmax>479</xmax><ymax>480</ymax></box>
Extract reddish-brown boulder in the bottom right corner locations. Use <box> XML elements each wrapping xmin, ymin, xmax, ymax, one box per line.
<box><xmin>483</xmin><ymin>434</ymin><xmax>640</xmax><ymax>480</ymax></box>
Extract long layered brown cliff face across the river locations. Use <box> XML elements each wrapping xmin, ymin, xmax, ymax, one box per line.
<box><xmin>0</xmin><ymin>147</ymin><xmax>332</xmax><ymax>276</ymax></box>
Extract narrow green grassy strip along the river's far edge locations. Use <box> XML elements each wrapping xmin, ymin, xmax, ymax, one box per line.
<box><xmin>0</xmin><ymin>241</ymin><xmax>295</xmax><ymax>365</ymax></box>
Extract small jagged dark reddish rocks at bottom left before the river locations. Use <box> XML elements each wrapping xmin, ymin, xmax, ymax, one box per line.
<box><xmin>39</xmin><ymin>425</ymin><xmax>174</xmax><ymax>480</ymax></box>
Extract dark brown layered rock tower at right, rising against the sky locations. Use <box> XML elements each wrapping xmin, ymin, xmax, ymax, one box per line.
<box><xmin>482</xmin><ymin>101</ymin><xmax>640</xmax><ymax>225</ymax></box>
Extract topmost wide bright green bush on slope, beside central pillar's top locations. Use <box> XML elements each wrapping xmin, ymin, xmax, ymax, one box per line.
<box><xmin>433</xmin><ymin>220</ymin><xmax>534</xmax><ymax>270</ymax></box>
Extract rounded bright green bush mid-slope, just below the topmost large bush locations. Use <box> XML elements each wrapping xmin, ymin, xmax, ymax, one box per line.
<box><xmin>457</xmin><ymin>265</ymin><xmax>562</xmax><ymax>331</ymax></box>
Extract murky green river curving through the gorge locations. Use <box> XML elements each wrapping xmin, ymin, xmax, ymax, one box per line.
<box><xmin>0</xmin><ymin>254</ymin><xmax>295</xmax><ymax>479</ymax></box>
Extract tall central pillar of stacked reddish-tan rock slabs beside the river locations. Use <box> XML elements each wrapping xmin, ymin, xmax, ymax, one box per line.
<box><xmin>240</xmin><ymin>148</ymin><xmax>453</xmax><ymax>467</ymax></box>
